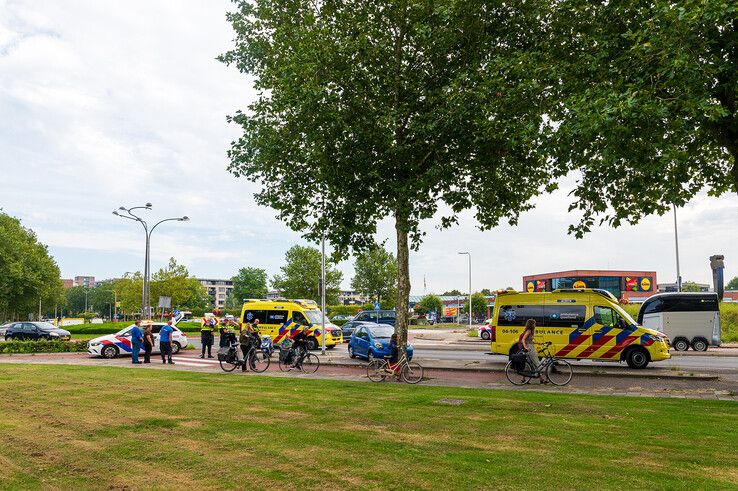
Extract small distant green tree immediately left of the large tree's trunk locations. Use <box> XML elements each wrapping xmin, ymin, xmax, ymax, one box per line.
<box><xmin>351</xmin><ymin>246</ymin><xmax>397</xmax><ymax>305</ymax></box>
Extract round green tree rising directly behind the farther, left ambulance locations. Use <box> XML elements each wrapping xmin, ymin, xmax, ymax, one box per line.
<box><xmin>272</xmin><ymin>245</ymin><xmax>343</xmax><ymax>305</ymax></box>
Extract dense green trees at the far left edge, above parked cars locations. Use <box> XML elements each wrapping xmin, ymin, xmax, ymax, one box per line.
<box><xmin>0</xmin><ymin>212</ymin><xmax>64</xmax><ymax>319</ymax></box>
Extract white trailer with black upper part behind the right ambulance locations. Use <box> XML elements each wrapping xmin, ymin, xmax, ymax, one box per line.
<box><xmin>638</xmin><ymin>293</ymin><xmax>720</xmax><ymax>351</ymax></box>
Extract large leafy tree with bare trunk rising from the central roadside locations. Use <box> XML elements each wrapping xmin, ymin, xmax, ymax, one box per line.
<box><xmin>220</xmin><ymin>0</ymin><xmax>553</xmax><ymax>349</ymax></box>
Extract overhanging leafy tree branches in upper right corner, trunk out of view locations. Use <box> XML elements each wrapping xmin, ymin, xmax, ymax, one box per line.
<box><xmin>549</xmin><ymin>0</ymin><xmax>738</xmax><ymax>236</ymax></box>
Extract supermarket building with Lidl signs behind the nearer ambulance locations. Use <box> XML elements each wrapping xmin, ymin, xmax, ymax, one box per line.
<box><xmin>523</xmin><ymin>269</ymin><xmax>657</xmax><ymax>301</ymax></box>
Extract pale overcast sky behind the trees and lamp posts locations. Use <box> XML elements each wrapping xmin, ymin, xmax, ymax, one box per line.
<box><xmin>0</xmin><ymin>0</ymin><xmax>738</xmax><ymax>294</ymax></box>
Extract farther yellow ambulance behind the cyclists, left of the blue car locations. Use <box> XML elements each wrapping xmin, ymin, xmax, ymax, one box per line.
<box><xmin>241</xmin><ymin>298</ymin><xmax>343</xmax><ymax>349</ymax></box>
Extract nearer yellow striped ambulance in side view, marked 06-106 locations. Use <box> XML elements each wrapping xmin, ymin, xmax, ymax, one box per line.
<box><xmin>490</xmin><ymin>288</ymin><xmax>671</xmax><ymax>368</ymax></box>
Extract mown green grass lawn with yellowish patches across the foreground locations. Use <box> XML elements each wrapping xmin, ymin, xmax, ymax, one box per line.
<box><xmin>0</xmin><ymin>364</ymin><xmax>738</xmax><ymax>489</ymax></box>
